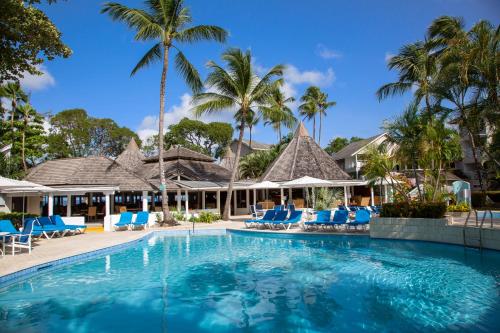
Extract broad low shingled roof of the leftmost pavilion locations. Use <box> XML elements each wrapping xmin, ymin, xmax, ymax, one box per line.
<box><xmin>25</xmin><ymin>156</ymin><xmax>155</xmax><ymax>191</ymax></box>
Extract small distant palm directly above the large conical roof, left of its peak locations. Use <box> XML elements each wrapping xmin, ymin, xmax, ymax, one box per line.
<box><xmin>260</xmin><ymin>88</ymin><xmax>297</xmax><ymax>142</ymax></box>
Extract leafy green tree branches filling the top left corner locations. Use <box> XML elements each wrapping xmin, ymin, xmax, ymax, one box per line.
<box><xmin>0</xmin><ymin>0</ymin><xmax>71</xmax><ymax>83</ymax></box>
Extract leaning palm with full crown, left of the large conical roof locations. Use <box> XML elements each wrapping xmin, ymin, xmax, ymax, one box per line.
<box><xmin>194</xmin><ymin>49</ymin><xmax>284</xmax><ymax>220</ymax></box>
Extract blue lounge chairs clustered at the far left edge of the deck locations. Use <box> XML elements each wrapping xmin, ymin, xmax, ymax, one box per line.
<box><xmin>0</xmin><ymin>215</ymin><xmax>87</xmax><ymax>255</ymax></box>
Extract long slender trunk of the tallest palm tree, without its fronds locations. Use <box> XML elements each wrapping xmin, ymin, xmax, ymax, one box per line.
<box><xmin>158</xmin><ymin>46</ymin><xmax>173</xmax><ymax>223</ymax></box>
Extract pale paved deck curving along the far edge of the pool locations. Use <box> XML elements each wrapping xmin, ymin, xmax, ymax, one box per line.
<box><xmin>0</xmin><ymin>220</ymin><xmax>368</xmax><ymax>277</ymax></box>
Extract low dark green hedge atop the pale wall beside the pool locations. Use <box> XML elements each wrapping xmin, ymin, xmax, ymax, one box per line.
<box><xmin>380</xmin><ymin>202</ymin><xmax>446</xmax><ymax>219</ymax></box>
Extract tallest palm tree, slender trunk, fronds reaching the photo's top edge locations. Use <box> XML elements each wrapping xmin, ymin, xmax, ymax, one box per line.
<box><xmin>102</xmin><ymin>0</ymin><xmax>227</xmax><ymax>221</ymax></box>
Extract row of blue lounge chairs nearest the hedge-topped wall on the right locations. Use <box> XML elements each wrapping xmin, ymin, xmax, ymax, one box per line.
<box><xmin>304</xmin><ymin>209</ymin><xmax>371</xmax><ymax>230</ymax></box>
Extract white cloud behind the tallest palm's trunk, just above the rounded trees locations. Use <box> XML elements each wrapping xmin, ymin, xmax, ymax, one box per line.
<box><xmin>136</xmin><ymin>93</ymin><xmax>233</xmax><ymax>141</ymax></box>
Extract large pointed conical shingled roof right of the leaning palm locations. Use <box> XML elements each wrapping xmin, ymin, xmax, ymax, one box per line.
<box><xmin>261</xmin><ymin>122</ymin><xmax>351</xmax><ymax>181</ymax></box>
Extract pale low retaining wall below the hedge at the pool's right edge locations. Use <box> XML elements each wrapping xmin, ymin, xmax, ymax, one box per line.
<box><xmin>370</xmin><ymin>217</ymin><xmax>500</xmax><ymax>250</ymax></box>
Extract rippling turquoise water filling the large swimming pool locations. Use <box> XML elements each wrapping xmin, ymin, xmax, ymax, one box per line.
<box><xmin>0</xmin><ymin>233</ymin><xmax>500</xmax><ymax>332</ymax></box>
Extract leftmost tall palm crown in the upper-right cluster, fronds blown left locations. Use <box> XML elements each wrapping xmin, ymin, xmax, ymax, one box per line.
<box><xmin>376</xmin><ymin>41</ymin><xmax>438</xmax><ymax>119</ymax></box>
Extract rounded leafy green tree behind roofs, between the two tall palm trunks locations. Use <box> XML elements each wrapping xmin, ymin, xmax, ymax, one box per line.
<box><xmin>165</xmin><ymin>118</ymin><xmax>233</xmax><ymax>158</ymax></box>
